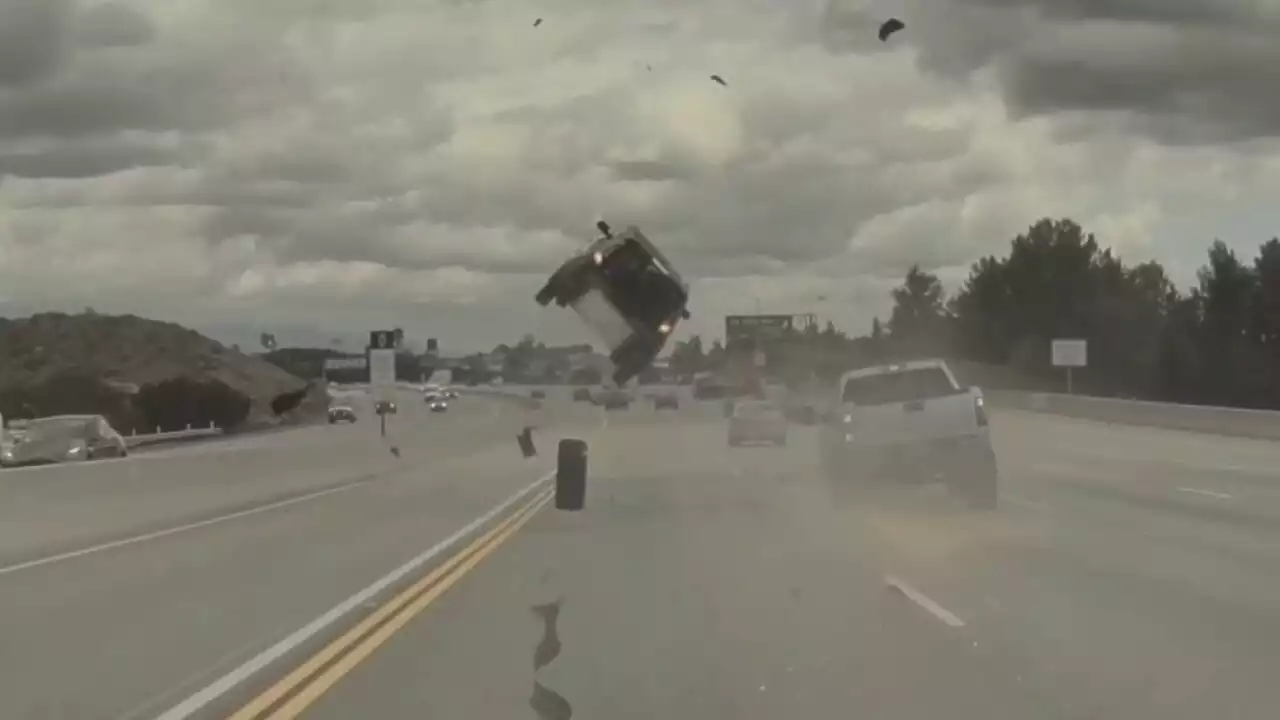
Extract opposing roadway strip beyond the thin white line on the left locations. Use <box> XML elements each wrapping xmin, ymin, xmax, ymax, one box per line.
<box><xmin>0</xmin><ymin>393</ymin><xmax>526</xmax><ymax>563</ymax></box>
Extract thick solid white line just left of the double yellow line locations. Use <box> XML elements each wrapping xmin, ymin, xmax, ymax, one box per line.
<box><xmin>156</xmin><ymin>470</ymin><xmax>556</xmax><ymax>720</ymax></box>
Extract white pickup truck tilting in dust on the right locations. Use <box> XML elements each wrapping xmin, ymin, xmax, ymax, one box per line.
<box><xmin>819</xmin><ymin>360</ymin><xmax>997</xmax><ymax>509</ymax></box>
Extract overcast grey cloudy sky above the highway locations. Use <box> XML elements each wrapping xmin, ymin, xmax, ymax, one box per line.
<box><xmin>0</xmin><ymin>0</ymin><xmax>1280</xmax><ymax>351</ymax></box>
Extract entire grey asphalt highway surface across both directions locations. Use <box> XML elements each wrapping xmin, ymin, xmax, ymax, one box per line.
<box><xmin>0</xmin><ymin>391</ymin><xmax>1280</xmax><ymax>720</ymax></box>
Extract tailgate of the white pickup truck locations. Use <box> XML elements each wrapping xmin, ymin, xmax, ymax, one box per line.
<box><xmin>842</xmin><ymin>391</ymin><xmax>978</xmax><ymax>445</ymax></box>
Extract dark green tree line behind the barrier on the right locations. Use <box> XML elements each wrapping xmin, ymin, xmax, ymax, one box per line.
<box><xmin>672</xmin><ymin>218</ymin><xmax>1280</xmax><ymax>409</ymax></box>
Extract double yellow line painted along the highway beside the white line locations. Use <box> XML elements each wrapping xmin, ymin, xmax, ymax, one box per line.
<box><xmin>229</xmin><ymin>488</ymin><xmax>554</xmax><ymax>720</ymax></box>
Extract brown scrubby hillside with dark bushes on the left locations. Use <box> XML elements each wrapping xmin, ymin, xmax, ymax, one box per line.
<box><xmin>0</xmin><ymin>313</ymin><xmax>328</xmax><ymax>433</ymax></box>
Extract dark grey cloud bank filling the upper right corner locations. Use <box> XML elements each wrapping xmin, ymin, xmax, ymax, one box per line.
<box><xmin>844</xmin><ymin>0</ymin><xmax>1280</xmax><ymax>145</ymax></box>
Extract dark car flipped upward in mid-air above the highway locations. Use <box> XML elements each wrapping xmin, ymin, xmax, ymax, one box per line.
<box><xmin>536</xmin><ymin>220</ymin><xmax>689</xmax><ymax>386</ymax></box>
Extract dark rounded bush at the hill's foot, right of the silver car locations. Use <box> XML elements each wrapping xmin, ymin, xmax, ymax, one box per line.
<box><xmin>133</xmin><ymin>377</ymin><xmax>250</xmax><ymax>432</ymax></box>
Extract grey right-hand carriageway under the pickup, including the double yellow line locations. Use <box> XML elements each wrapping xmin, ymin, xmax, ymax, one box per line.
<box><xmin>235</xmin><ymin>397</ymin><xmax>1280</xmax><ymax>720</ymax></box>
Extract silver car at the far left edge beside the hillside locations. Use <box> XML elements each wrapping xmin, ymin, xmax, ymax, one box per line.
<box><xmin>0</xmin><ymin>415</ymin><xmax>129</xmax><ymax>468</ymax></box>
